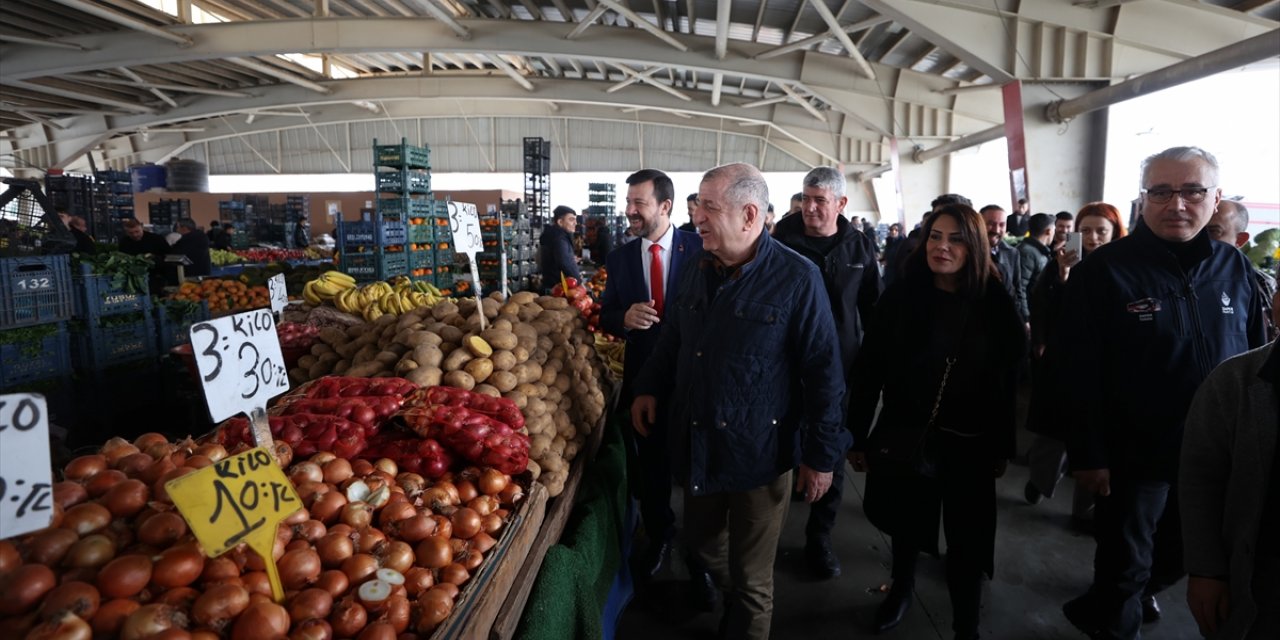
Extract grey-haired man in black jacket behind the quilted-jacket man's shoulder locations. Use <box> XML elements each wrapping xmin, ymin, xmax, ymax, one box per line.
<box><xmin>773</xmin><ymin>166</ymin><xmax>882</xmax><ymax>580</ymax></box>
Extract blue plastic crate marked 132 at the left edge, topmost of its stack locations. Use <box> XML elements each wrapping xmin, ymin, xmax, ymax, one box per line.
<box><xmin>0</xmin><ymin>256</ymin><xmax>72</xmax><ymax>328</ymax></box>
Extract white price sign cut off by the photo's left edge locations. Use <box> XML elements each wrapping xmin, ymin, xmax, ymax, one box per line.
<box><xmin>0</xmin><ymin>393</ymin><xmax>54</xmax><ymax>539</ymax></box>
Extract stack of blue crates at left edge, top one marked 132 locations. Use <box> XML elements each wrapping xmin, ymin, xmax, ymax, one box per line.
<box><xmin>0</xmin><ymin>255</ymin><xmax>72</xmax><ymax>390</ymax></box>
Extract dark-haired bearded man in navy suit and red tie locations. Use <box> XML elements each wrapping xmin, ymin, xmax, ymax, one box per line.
<box><xmin>600</xmin><ymin>169</ymin><xmax>705</xmax><ymax>585</ymax></box>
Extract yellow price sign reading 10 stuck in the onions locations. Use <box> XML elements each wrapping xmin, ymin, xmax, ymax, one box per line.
<box><xmin>165</xmin><ymin>447</ymin><xmax>302</xmax><ymax>603</ymax></box>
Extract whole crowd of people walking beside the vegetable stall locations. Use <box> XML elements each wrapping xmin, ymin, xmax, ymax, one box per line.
<box><xmin>603</xmin><ymin>147</ymin><xmax>1280</xmax><ymax>640</ymax></box>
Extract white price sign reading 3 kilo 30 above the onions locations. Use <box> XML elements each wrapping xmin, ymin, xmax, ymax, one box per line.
<box><xmin>191</xmin><ymin>308</ymin><xmax>289</xmax><ymax>447</ymax></box>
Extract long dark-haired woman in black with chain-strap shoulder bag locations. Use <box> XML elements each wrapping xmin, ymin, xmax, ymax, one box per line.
<box><xmin>847</xmin><ymin>204</ymin><xmax>1024</xmax><ymax>640</ymax></box>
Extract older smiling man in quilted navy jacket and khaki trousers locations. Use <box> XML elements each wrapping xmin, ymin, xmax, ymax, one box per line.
<box><xmin>631</xmin><ymin>164</ymin><xmax>845</xmax><ymax>640</ymax></box>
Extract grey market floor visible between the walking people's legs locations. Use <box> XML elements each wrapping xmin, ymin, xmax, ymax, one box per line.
<box><xmin>616</xmin><ymin>434</ymin><xmax>1201</xmax><ymax>640</ymax></box>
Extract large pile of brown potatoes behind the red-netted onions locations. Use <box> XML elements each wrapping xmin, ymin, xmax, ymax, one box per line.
<box><xmin>289</xmin><ymin>292</ymin><xmax>605</xmax><ymax>497</ymax></box>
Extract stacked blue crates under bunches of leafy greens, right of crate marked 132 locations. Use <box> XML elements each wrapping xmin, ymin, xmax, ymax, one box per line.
<box><xmin>70</xmin><ymin>264</ymin><xmax>156</xmax><ymax>374</ymax></box>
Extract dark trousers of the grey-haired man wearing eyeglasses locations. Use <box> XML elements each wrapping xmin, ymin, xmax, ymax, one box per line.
<box><xmin>1089</xmin><ymin>478</ymin><xmax>1183</xmax><ymax>640</ymax></box>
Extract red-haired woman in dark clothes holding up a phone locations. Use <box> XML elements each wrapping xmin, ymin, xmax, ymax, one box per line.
<box><xmin>1023</xmin><ymin>202</ymin><xmax>1124</xmax><ymax>521</ymax></box>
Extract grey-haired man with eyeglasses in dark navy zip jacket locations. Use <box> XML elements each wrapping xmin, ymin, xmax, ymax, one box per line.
<box><xmin>1062</xmin><ymin>147</ymin><xmax>1266</xmax><ymax>640</ymax></box>
